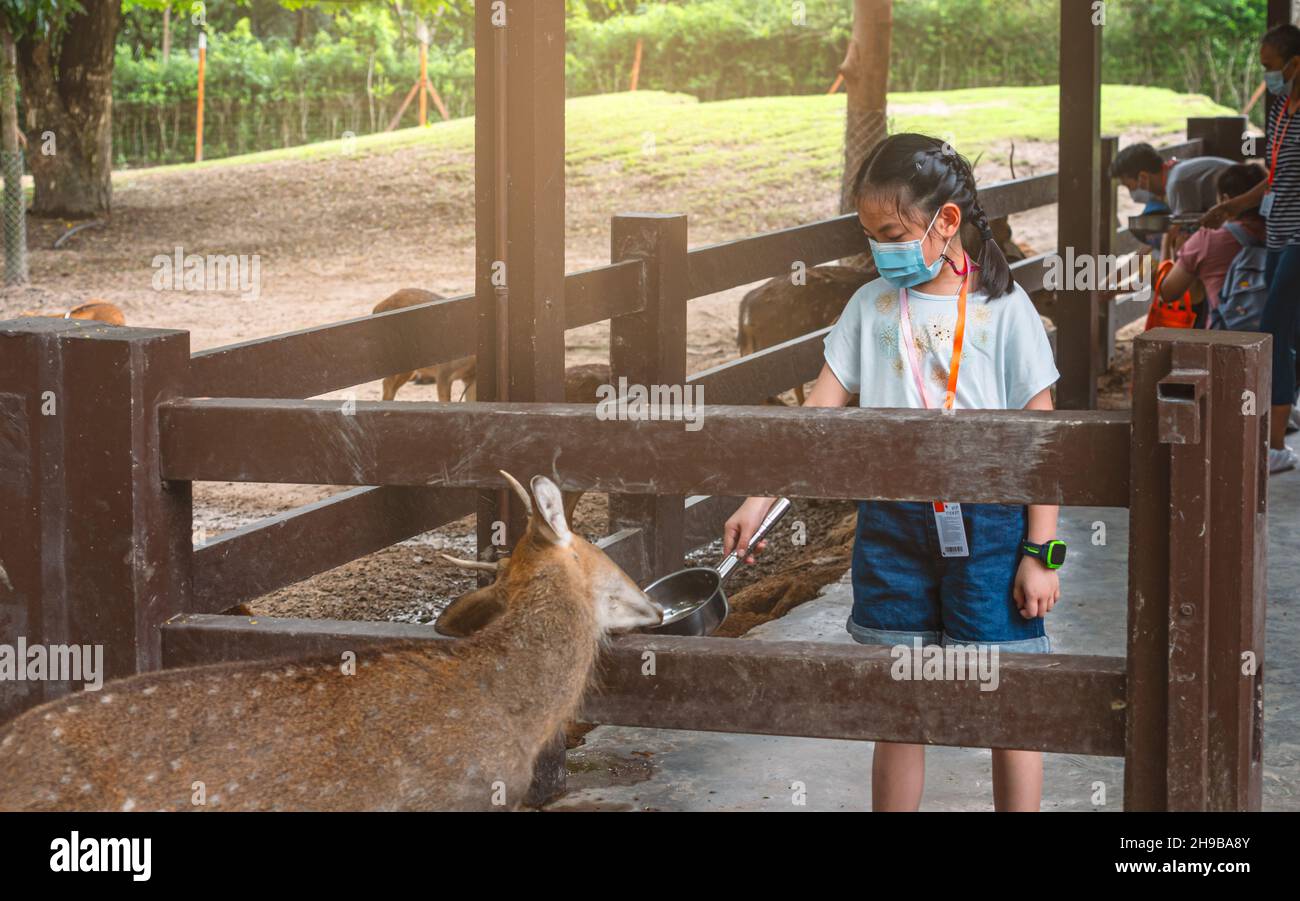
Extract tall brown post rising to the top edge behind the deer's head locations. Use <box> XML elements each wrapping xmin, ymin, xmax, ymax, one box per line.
<box><xmin>475</xmin><ymin>0</ymin><xmax>566</xmax><ymax>806</ymax></box>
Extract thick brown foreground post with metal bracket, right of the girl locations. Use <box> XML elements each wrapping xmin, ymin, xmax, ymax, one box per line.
<box><xmin>1125</xmin><ymin>329</ymin><xmax>1271</xmax><ymax>810</ymax></box>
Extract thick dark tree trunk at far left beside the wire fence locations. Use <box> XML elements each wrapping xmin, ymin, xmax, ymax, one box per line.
<box><xmin>18</xmin><ymin>0</ymin><xmax>122</xmax><ymax>218</ymax></box>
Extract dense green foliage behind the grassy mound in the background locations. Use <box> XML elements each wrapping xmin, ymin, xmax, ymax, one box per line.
<box><xmin>109</xmin><ymin>0</ymin><xmax>1266</xmax><ymax>163</ymax></box>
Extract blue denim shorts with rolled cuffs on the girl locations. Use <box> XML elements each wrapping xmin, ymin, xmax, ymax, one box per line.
<box><xmin>848</xmin><ymin>501</ymin><xmax>1052</xmax><ymax>654</ymax></box>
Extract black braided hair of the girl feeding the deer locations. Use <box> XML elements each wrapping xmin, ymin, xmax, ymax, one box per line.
<box><xmin>853</xmin><ymin>134</ymin><xmax>1014</xmax><ymax>298</ymax></box>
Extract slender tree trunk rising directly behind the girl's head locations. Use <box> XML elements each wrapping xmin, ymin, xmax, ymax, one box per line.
<box><xmin>840</xmin><ymin>0</ymin><xmax>893</xmax><ymax>213</ymax></box>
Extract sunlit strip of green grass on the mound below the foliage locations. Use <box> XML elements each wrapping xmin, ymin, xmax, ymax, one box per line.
<box><xmin>124</xmin><ymin>85</ymin><xmax>1232</xmax><ymax>190</ymax></box>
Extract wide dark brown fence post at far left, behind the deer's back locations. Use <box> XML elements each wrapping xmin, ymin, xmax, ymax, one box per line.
<box><xmin>0</xmin><ymin>319</ymin><xmax>192</xmax><ymax>720</ymax></box>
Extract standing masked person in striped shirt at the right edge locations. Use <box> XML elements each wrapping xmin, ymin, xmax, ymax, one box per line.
<box><xmin>1201</xmin><ymin>25</ymin><xmax>1300</xmax><ymax>475</ymax></box>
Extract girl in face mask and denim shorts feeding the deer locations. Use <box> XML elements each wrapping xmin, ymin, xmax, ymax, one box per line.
<box><xmin>723</xmin><ymin>134</ymin><xmax>1063</xmax><ymax>810</ymax></box>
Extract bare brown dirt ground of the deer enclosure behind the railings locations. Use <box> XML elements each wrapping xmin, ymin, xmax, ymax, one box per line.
<box><xmin>0</xmin><ymin>128</ymin><xmax>1159</xmax><ymax>633</ymax></box>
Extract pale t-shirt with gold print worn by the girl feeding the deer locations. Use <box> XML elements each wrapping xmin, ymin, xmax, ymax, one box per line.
<box><xmin>826</xmin><ymin>278</ymin><xmax>1061</xmax><ymax>410</ymax></box>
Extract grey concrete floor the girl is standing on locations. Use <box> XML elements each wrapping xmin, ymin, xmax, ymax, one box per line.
<box><xmin>551</xmin><ymin>472</ymin><xmax>1300</xmax><ymax>810</ymax></box>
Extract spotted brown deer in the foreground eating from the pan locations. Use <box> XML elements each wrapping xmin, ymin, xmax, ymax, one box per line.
<box><xmin>0</xmin><ymin>473</ymin><xmax>663</xmax><ymax>810</ymax></box>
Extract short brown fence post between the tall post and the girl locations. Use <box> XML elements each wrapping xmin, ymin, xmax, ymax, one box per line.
<box><xmin>610</xmin><ymin>213</ymin><xmax>691</xmax><ymax>577</ymax></box>
